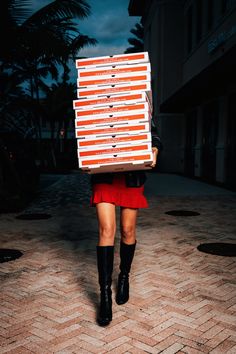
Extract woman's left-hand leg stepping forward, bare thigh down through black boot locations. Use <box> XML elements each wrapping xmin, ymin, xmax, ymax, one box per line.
<box><xmin>96</xmin><ymin>203</ymin><xmax>116</xmax><ymax>326</ymax></box>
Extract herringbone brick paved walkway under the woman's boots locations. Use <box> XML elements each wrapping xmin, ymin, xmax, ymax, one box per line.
<box><xmin>0</xmin><ymin>173</ymin><xmax>236</xmax><ymax>354</ymax></box>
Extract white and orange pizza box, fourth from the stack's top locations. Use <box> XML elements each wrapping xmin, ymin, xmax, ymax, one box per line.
<box><xmin>77</xmin><ymin>81</ymin><xmax>152</xmax><ymax>98</ymax></box>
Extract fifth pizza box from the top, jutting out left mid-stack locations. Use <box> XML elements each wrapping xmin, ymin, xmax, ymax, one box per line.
<box><xmin>73</xmin><ymin>92</ymin><xmax>149</xmax><ymax>110</ymax></box>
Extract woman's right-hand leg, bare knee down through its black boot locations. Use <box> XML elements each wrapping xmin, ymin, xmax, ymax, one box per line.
<box><xmin>116</xmin><ymin>208</ymin><xmax>138</xmax><ymax>305</ymax></box>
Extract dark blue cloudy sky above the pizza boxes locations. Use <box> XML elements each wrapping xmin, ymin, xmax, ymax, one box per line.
<box><xmin>32</xmin><ymin>0</ymin><xmax>140</xmax><ymax>57</ymax></box>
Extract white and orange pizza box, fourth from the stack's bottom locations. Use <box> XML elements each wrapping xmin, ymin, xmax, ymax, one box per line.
<box><xmin>75</xmin><ymin>122</ymin><xmax>151</xmax><ymax>139</ymax></box>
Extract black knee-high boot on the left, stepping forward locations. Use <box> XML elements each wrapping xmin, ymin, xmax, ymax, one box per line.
<box><xmin>97</xmin><ymin>246</ymin><xmax>114</xmax><ymax>326</ymax></box>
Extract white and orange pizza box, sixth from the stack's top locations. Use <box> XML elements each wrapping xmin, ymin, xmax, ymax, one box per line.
<box><xmin>75</xmin><ymin>102</ymin><xmax>150</xmax><ymax>118</ymax></box>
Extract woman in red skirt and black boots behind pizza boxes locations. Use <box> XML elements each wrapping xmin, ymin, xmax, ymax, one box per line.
<box><xmin>91</xmin><ymin>133</ymin><xmax>161</xmax><ymax>326</ymax></box>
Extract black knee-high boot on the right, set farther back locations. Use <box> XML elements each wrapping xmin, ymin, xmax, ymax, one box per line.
<box><xmin>116</xmin><ymin>241</ymin><xmax>136</xmax><ymax>305</ymax></box>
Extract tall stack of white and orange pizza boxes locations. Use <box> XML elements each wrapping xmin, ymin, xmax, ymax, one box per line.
<box><xmin>73</xmin><ymin>52</ymin><xmax>152</xmax><ymax>174</ymax></box>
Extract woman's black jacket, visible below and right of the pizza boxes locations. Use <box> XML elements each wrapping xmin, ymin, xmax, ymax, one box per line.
<box><xmin>91</xmin><ymin>132</ymin><xmax>163</xmax><ymax>188</ymax></box>
